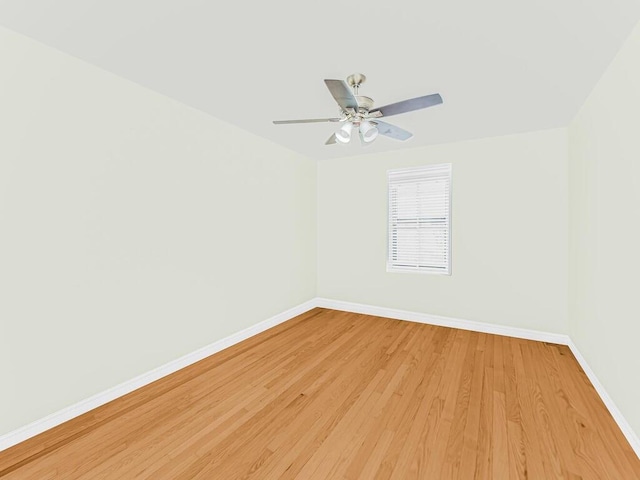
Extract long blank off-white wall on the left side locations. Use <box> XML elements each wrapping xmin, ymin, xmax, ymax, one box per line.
<box><xmin>0</xmin><ymin>29</ymin><xmax>316</xmax><ymax>435</ymax></box>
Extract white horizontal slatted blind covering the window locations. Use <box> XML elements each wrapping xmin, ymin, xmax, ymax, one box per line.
<box><xmin>387</xmin><ymin>163</ymin><xmax>451</xmax><ymax>275</ymax></box>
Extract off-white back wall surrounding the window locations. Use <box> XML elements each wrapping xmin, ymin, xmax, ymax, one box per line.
<box><xmin>318</xmin><ymin>129</ymin><xmax>568</xmax><ymax>333</ymax></box>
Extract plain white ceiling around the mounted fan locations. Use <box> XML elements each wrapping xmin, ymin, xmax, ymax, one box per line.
<box><xmin>0</xmin><ymin>0</ymin><xmax>640</xmax><ymax>158</ymax></box>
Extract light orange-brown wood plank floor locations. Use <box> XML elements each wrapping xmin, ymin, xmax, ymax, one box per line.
<box><xmin>0</xmin><ymin>309</ymin><xmax>640</xmax><ymax>480</ymax></box>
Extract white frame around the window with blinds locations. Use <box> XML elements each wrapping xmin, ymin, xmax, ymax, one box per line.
<box><xmin>386</xmin><ymin>163</ymin><xmax>453</xmax><ymax>276</ymax></box>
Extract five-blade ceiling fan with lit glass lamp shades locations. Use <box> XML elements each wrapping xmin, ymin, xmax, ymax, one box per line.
<box><xmin>273</xmin><ymin>73</ymin><xmax>442</xmax><ymax>145</ymax></box>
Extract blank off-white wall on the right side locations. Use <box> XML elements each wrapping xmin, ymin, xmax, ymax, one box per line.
<box><xmin>569</xmin><ymin>21</ymin><xmax>640</xmax><ymax>437</ymax></box>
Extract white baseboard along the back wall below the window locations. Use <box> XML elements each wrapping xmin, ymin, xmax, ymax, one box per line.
<box><xmin>316</xmin><ymin>298</ymin><xmax>569</xmax><ymax>345</ymax></box>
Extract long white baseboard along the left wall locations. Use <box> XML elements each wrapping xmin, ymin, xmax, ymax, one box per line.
<box><xmin>0</xmin><ymin>299</ymin><xmax>316</xmax><ymax>452</ymax></box>
